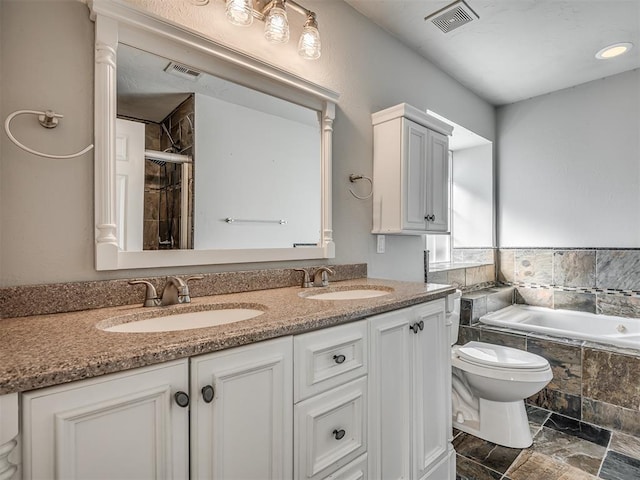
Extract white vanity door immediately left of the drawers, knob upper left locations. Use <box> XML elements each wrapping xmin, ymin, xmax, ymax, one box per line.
<box><xmin>191</xmin><ymin>337</ymin><xmax>293</xmax><ymax>480</ymax></box>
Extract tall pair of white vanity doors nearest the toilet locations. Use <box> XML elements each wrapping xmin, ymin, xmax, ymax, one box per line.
<box><xmin>369</xmin><ymin>300</ymin><xmax>455</xmax><ymax>480</ymax></box>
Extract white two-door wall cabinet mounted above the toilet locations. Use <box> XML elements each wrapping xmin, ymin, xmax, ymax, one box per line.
<box><xmin>372</xmin><ymin>103</ymin><xmax>452</xmax><ymax>235</ymax></box>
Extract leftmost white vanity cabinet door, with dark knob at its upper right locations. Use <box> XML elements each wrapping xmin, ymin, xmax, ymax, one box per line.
<box><xmin>22</xmin><ymin>360</ymin><xmax>189</xmax><ymax>480</ymax></box>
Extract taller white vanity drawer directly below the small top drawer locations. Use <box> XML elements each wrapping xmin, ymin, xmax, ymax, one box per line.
<box><xmin>293</xmin><ymin>377</ymin><xmax>367</xmax><ymax>480</ymax></box>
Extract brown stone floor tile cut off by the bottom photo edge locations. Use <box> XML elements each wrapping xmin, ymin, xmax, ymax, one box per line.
<box><xmin>507</xmin><ymin>449</ymin><xmax>597</xmax><ymax>480</ymax></box>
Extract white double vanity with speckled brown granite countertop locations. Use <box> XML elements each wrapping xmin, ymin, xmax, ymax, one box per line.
<box><xmin>0</xmin><ymin>279</ymin><xmax>455</xmax><ymax>480</ymax></box>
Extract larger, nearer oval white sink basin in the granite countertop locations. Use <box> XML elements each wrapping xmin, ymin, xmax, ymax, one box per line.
<box><xmin>98</xmin><ymin>308</ymin><xmax>264</xmax><ymax>333</ymax></box>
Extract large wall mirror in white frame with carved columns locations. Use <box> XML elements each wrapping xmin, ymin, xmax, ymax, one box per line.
<box><xmin>91</xmin><ymin>0</ymin><xmax>337</xmax><ymax>270</ymax></box>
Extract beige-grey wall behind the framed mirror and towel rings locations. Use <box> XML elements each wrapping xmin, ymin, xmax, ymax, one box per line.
<box><xmin>0</xmin><ymin>0</ymin><xmax>495</xmax><ymax>286</ymax></box>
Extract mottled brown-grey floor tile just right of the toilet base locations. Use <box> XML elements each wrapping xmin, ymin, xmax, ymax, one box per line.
<box><xmin>529</xmin><ymin>427</ymin><xmax>606</xmax><ymax>475</ymax></box>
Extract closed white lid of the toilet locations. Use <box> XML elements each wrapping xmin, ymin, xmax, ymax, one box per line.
<box><xmin>457</xmin><ymin>342</ymin><xmax>549</xmax><ymax>370</ymax></box>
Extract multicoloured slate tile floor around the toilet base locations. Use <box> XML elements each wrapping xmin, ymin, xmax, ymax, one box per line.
<box><xmin>453</xmin><ymin>406</ymin><xmax>640</xmax><ymax>480</ymax></box>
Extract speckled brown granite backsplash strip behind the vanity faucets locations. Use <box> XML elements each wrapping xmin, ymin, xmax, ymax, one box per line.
<box><xmin>0</xmin><ymin>263</ymin><xmax>367</xmax><ymax>318</ymax></box>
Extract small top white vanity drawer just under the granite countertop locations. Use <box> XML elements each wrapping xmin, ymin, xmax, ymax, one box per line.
<box><xmin>294</xmin><ymin>320</ymin><xmax>367</xmax><ymax>402</ymax></box>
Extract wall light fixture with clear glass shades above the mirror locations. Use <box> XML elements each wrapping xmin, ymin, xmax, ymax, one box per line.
<box><xmin>221</xmin><ymin>0</ymin><xmax>321</xmax><ymax>60</ymax></box>
